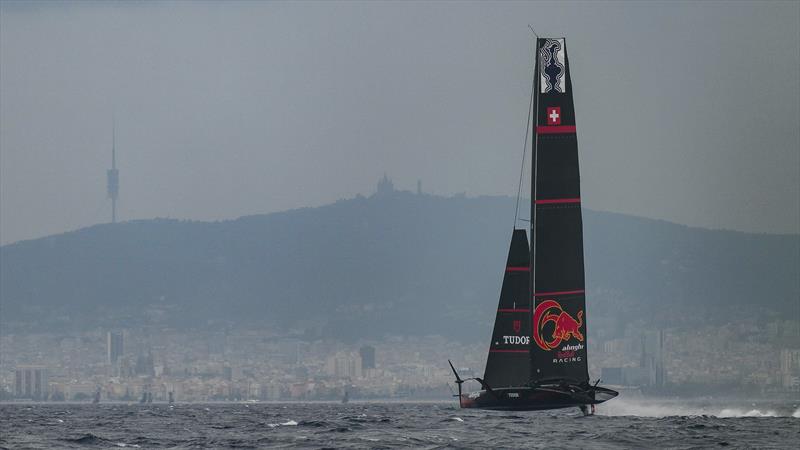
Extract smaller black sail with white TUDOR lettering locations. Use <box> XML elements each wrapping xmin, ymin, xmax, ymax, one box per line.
<box><xmin>483</xmin><ymin>230</ymin><xmax>531</xmax><ymax>388</ymax></box>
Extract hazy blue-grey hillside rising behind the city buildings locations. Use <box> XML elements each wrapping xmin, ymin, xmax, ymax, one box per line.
<box><xmin>0</xmin><ymin>191</ymin><xmax>800</xmax><ymax>337</ymax></box>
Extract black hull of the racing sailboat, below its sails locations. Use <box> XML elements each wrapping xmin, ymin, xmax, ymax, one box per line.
<box><xmin>459</xmin><ymin>386</ymin><xmax>619</xmax><ymax>411</ymax></box>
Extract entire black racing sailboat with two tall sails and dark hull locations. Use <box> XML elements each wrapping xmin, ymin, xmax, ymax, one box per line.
<box><xmin>448</xmin><ymin>37</ymin><xmax>618</xmax><ymax>414</ymax></box>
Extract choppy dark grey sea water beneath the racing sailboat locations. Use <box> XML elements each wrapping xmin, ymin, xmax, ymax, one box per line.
<box><xmin>0</xmin><ymin>399</ymin><xmax>800</xmax><ymax>449</ymax></box>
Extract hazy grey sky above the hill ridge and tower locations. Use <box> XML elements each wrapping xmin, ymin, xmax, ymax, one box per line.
<box><xmin>0</xmin><ymin>1</ymin><xmax>800</xmax><ymax>243</ymax></box>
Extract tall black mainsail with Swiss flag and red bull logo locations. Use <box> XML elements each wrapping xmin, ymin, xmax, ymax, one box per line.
<box><xmin>530</xmin><ymin>39</ymin><xmax>589</xmax><ymax>382</ymax></box>
